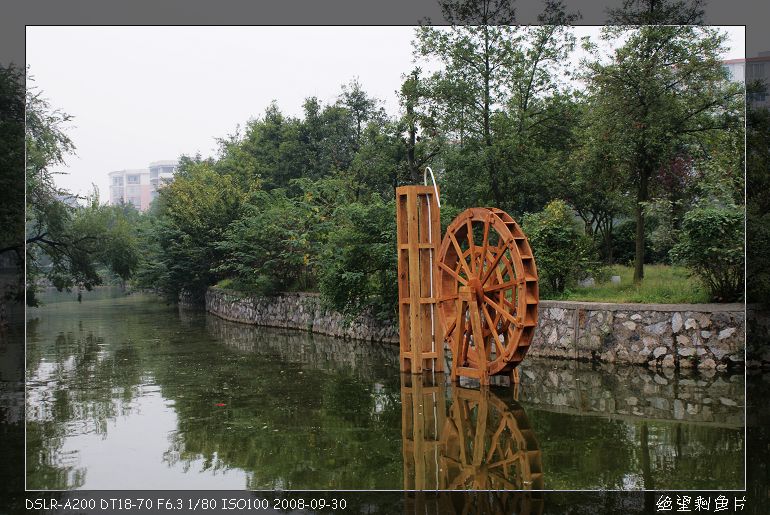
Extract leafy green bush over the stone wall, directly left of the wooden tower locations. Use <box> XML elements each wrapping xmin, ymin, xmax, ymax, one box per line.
<box><xmin>320</xmin><ymin>196</ymin><xmax>398</xmax><ymax>319</ymax></box>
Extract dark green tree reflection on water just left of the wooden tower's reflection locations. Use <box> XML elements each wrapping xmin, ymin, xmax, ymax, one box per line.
<box><xmin>148</xmin><ymin>319</ymin><xmax>400</xmax><ymax>488</ymax></box>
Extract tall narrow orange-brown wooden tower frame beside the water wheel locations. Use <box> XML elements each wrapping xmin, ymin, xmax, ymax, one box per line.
<box><xmin>396</xmin><ymin>186</ymin><xmax>444</xmax><ymax>374</ymax></box>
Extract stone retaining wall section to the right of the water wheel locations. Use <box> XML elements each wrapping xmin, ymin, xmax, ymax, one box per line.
<box><xmin>529</xmin><ymin>301</ymin><xmax>746</xmax><ymax>369</ymax></box>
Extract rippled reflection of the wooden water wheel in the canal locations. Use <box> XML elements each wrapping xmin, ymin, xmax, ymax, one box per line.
<box><xmin>441</xmin><ymin>387</ymin><xmax>543</xmax><ymax>490</ymax></box>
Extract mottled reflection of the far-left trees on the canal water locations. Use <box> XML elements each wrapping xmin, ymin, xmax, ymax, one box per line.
<box><xmin>26</xmin><ymin>296</ymin><xmax>166</xmax><ymax>490</ymax></box>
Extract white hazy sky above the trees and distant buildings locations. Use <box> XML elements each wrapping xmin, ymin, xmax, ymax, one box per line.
<box><xmin>27</xmin><ymin>27</ymin><xmax>744</xmax><ymax>201</ymax></box>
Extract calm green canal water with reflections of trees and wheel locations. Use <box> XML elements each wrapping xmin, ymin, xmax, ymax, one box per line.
<box><xmin>25</xmin><ymin>289</ymin><xmax>745</xmax><ymax>490</ymax></box>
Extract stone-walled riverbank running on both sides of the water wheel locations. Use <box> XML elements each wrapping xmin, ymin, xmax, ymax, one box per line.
<box><xmin>205</xmin><ymin>287</ymin><xmax>752</xmax><ymax>370</ymax></box>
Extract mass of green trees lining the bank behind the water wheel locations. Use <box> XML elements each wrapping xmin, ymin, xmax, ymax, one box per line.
<box><xmin>123</xmin><ymin>24</ymin><xmax>743</xmax><ymax>308</ymax></box>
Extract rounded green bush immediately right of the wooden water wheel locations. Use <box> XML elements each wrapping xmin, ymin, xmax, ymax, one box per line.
<box><xmin>522</xmin><ymin>200</ymin><xmax>597</xmax><ymax>294</ymax></box>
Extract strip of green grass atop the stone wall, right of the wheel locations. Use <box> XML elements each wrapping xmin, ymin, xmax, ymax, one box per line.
<box><xmin>544</xmin><ymin>265</ymin><xmax>710</xmax><ymax>304</ymax></box>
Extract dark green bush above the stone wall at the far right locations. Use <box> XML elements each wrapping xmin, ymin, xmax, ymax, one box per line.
<box><xmin>671</xmin><ymin>205</ymin><xmax>745</xmax><ymax>302</ymax></box>
